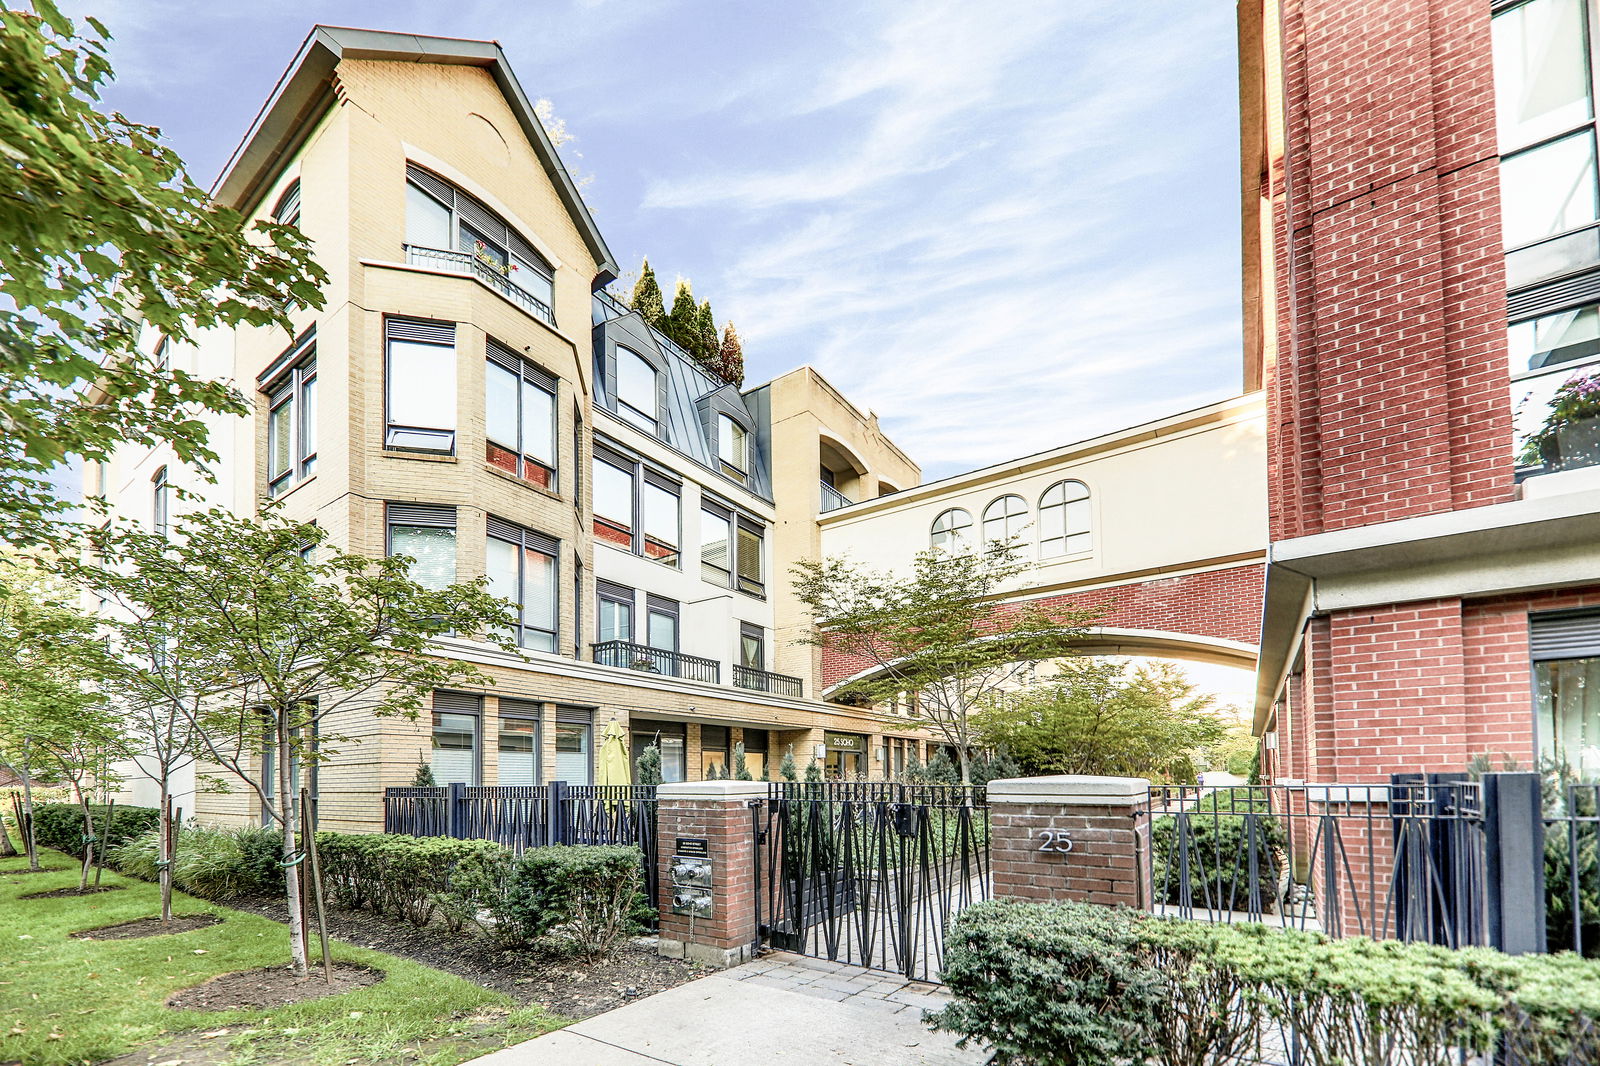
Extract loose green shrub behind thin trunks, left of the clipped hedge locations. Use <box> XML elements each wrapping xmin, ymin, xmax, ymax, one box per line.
<box><xmin>110</xmin><ymin>826</ymin><xmax>283</xmax><ymax>900</ymax></box>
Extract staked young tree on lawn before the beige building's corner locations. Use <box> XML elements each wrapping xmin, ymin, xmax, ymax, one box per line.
<box><xmin>87</xmin><ymin>509</ymin><xmax>510</xmax><ymax>976</ymax></box>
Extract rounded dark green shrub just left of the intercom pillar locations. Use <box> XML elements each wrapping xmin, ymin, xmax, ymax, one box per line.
<box><xmin>483</xmin><ymin>845</ymin><xmax>643</xmax><ymax>959</ymax></box>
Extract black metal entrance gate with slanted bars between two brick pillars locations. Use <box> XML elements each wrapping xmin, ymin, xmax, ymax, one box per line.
<box><xmin>750</xmin><ymin>781</ymin><xmax>990</xmax><ymax>981</ymax></box>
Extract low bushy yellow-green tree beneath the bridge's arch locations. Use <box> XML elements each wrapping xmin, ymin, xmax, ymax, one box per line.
<box><xmin>974</xmin><ymin>658</ymin><xmax>1227</xmax><ymax>781</ymax></box>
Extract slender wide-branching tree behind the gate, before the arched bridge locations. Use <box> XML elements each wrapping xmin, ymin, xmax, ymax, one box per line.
<box><xmin>792</xmin><ymin>541</ymin><xmax>1102</xmax><ymax>784</ymax></box>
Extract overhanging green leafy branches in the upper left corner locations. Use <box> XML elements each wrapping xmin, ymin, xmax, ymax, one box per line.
<box><xmin>0</xmin><ymin>0</ymin><xmax>326</xmax><ymax>543</ymax></box>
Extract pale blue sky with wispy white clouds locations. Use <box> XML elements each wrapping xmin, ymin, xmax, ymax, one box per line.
<box><xmin>62</xmin><ymin>0</ymin><xmax>1240</xmax><ymax>480</ymax></box>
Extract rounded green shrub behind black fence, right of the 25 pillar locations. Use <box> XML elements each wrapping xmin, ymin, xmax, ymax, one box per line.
<box><xmin>1150</xmin><ymin>789</ymin><xmax>1285</xmax><ymax>911</ymax></box>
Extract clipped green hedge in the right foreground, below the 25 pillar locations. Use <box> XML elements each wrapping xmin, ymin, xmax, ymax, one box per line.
<box><xmin>930</xmin><ymin>901</ymin><xmax>1600</xmax><ymax>1066</ymax></box>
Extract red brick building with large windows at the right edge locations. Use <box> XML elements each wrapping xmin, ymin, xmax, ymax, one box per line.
<box><xmin>1238</xmin><ymin>0</ymin><xmax>1600</xmax><ymax>781</ymax></box>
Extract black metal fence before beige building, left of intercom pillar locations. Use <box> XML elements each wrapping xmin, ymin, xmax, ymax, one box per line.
<box><xmin>384</xmin><ymin>781</ymin><xmax>659</xmax><ymax>909</ymax></box>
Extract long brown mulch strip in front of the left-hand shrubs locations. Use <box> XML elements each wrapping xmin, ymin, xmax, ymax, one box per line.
<box><xmin>230</xmin><ymin>900</ymin><xmax>709</xmax><ymax>1018</ymax></box>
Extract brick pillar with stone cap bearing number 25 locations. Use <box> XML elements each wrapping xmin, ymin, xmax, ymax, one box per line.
<box><xmin>989</xmin><ymin>775</ymin><xmax>1150</xmax><ymax>908</ymax></box>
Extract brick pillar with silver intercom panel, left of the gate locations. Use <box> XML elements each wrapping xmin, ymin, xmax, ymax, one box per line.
<box><xmin>656</xmin><ymin>781</ymin><xmax>766</xmax><ymax>967</ymax></box>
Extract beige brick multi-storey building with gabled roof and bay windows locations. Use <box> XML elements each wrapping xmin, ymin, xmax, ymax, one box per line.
<box><xmin>96</xmin><ymin>27</ymin><xmax>920</xmax><ymax>829</ymax></box>
